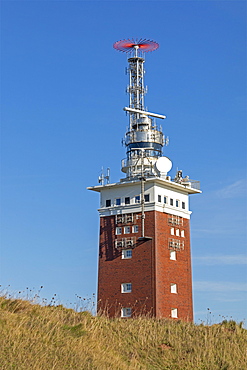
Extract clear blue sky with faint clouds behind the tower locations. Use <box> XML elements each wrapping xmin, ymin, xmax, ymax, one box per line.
<box><xmin>0</xmin><ymin>1</ymin><xmax>247</xmax><ymax>322</ymax></box>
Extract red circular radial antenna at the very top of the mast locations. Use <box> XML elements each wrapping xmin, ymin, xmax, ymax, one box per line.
<box><xmin>113</xmin><ymin>39</ymin><xmax>159</xmax><ymax>53</ymax></box>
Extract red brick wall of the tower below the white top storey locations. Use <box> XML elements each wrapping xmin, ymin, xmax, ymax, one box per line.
<box><xmin>98</xmin><ymin>211</ymin><xmax>193</xmax><ymax>321</ymax></box>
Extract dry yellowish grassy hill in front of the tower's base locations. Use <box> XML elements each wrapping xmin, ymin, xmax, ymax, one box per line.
<box><xmin>0</xmin><ymin>297</ymin><xmax>247</xmax><ymax>370</ymax></box>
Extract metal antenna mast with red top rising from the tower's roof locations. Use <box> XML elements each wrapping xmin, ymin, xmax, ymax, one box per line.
<box><xmin>113</xmin><ymin>39</ymin><xmax>166</xmax><ymax>181</ymax></box>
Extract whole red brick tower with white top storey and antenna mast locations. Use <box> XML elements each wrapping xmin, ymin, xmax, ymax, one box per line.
<box><xmin>88</xmin><ymin>39</ymin><xmax>201</xmax><ymax>321</ymax></box>
